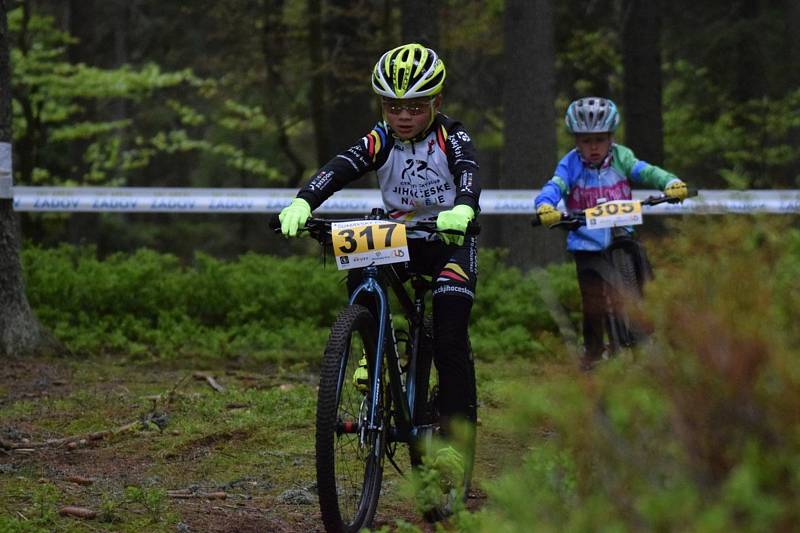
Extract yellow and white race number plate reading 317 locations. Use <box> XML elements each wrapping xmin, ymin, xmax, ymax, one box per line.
<box><xmin>331</xmin><ymin>220</ymin><xmax>408</xmax><ymax>270</ymax></box>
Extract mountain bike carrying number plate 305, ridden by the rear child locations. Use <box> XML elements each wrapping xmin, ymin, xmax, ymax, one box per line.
<box><xmin>531</xmin><ymin>190</ymin><xmax>697</xmax><ymax>357</ymax></box>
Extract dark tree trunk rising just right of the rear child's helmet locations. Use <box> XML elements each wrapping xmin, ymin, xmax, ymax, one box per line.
<box><xmin>622</xmin><ymin>0</ymin><xmax>664</xmax><ymax>165</ymax></box>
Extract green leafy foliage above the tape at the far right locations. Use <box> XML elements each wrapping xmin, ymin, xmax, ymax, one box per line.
<box><xmin>664</xmin><ymin>61</ymin><xmax>800</xmax><ymax>189</ymax></box>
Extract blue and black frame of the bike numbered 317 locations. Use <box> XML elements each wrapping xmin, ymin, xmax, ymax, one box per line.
<box><xmin>346</xmin><ymin>266</ymin><xmax>427</xmax><ymax>443</ymax></box>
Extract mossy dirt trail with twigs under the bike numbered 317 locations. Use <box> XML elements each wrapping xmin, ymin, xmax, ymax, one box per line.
<box><xmin>0</xmin><ymin>360</ymin><xmax>532</xmax><ymax>532</ymax></box>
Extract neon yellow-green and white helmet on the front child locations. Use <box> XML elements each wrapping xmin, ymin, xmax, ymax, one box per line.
<box><xmin>372</xmin><ymin>43</ymin><xmax>445</xmax><ymax>99</ymax></box>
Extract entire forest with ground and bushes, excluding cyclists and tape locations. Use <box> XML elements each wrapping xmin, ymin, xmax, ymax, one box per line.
<box><xmin>0</xmin><ymin>0</ymin><xmax>800</xmax><ymax>532</ymax></box>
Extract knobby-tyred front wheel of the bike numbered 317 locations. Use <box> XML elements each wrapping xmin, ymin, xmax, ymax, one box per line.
<box><xmin>316</xmin><ymin>305</ymin><xmax>386</xmax><ymax>532</ymax></box>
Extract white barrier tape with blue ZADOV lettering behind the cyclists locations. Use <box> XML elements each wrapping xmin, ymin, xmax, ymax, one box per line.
<box><xmin>12</xmin><ymin>187</ymin><xmax>800</xmax><ymax>215</ymax></box>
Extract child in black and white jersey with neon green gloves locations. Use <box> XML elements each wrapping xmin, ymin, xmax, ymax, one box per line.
<box><xmin>280</xmin><ymin>43</ymin><xmax>480</xmax><ymax>488</ymax></box>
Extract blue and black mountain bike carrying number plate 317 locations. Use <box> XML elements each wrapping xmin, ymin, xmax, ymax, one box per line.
<box><xmin>270</xmin><ymin>210</ymin><xmax>479</xmax><ymax>532</ymax></box>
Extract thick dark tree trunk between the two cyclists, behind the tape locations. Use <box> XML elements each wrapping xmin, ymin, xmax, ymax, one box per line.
<box><xmin>499</xmin><ymin>0</ymin><xmax>566</xmax><ymax>269</ymax></box>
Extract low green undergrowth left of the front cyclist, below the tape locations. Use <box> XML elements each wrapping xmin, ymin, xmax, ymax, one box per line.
<box><xmin>23</xmin><ymin>246</ymin><xmax>344</xmax><ymax>357</ymax></box>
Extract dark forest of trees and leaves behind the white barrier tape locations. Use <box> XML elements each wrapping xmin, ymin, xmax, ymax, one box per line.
<box><xmin>6</xmin><ymin>0</ymin><xmax>800</xmax><ymax>268</ymax></box>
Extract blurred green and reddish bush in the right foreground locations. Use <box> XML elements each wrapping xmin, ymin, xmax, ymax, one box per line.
<box><xmin>462</xmin><ymin>219</ymin><xmax>800</xmax><ymax>531</ymax></box>
